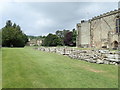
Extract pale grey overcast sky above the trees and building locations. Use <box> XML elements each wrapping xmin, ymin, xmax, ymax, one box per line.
<box><xmin>0</xmin><ymin>2</ymin><xmax>118</xmax><ymax>35</ymax></box>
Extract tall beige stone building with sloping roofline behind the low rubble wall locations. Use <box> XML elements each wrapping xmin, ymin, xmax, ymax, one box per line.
<box><xmin>76</xmin><ymin>9</ymin><xmax>120</xmax><ymax>48</ymax></box>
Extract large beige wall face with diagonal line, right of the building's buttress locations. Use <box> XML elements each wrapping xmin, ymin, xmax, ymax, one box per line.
<box><xmin>91</xmin><ymin>14</ymin><xmax>116</xmax><ymax>48</ymax></box>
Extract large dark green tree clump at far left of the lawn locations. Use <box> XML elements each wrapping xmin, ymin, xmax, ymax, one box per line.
<box><xmin>2</xmin><ymin>20</ymin><xmax>28</xmax><ymax>47</ymax></box>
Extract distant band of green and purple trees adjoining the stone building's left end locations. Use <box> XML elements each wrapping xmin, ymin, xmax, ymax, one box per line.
<box><xmin>28</xmin><ymin>29</ymin><xmax>77</xmax><ymax>46</ymax></box>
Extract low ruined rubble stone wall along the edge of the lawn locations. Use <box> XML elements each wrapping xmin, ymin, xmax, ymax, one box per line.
<box><xmin>35</xmin><ymin>47</ymin><xmax>120</xmax><ymax>65</ymax></box>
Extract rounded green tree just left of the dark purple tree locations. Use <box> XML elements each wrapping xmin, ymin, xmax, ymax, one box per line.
<box><xmin>44</xmin><ymin>34</ymin><xmax>62</xmax><ymax>46</ymax></box>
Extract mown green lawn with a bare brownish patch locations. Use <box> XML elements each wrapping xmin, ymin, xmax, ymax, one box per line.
<box><xmin>2</xmin><ymin>47</ymin><xmax>118</xmax><ymax>88</ymax></box>
